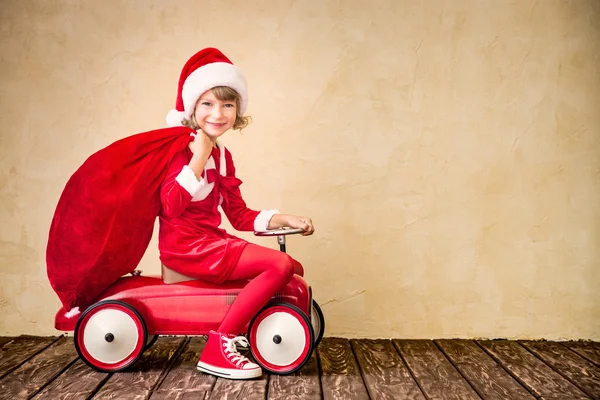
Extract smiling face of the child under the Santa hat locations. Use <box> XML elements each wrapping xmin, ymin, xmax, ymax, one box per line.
<box><xmin>194</xmin><ymin>90</ymin><xmax>236</xmax><ymax>140</ymax></box>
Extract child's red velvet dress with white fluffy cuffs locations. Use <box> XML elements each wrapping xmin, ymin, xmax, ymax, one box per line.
<box><xmin>158</xmin><ymin>145</ymin><xmax>273</xmax><ymax>283</ymax></box>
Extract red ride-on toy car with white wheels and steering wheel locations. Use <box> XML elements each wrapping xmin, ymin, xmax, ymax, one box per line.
<box><xmin>55</xmin><ymin>229</ymin><xmax>325</xmax><ymax>375</ymax></box>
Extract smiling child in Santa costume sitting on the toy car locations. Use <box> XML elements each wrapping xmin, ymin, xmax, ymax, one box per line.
<box><xmin>159</xmin><ymin>48</ymin><xmax>314</xmax><ymax>379</ymax></box>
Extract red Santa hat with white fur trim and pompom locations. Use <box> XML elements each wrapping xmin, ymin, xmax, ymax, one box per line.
<box><xmin>167</xmin><ymin>48</ymin><xmax>248</xmax><ymax>126</ymax></box>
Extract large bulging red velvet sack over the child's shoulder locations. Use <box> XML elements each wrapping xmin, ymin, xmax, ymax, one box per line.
<box><xmin>46</xmin><ymin>126</ymin><xmax>193</xmax><ymax>311</ymax></box>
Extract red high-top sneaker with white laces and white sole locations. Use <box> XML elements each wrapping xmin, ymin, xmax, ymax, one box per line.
<box><xmin>196</xmin><ymin>331</ymin><xmax>262</xmax><ymax>379</ymax></box>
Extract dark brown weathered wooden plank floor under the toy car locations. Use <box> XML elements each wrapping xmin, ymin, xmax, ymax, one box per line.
<box><xmin>0</xmin><ymin>336</ymin><xmax>600</xmax><ymax>400</ymax></box>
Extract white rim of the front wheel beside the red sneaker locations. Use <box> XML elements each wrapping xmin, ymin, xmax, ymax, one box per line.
<box><xmin>256</xmin><ymin>312</ymin><xmax>306</xmax><ymax>367</ymax></box>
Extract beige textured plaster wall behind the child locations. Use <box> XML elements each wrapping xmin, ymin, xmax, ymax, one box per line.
<box><xmin>0</xmin><ymin>0</ymin><xmax>600</xmax><ymax>340</ymax></box>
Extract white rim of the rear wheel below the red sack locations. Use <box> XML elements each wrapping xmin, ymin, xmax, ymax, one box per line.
<box><xmin>83</xmin><ymin>309</ymin><xmax>139</xmax><ymax>364</ymax></box>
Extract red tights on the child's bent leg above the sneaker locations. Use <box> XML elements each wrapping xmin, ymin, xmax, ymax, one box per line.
<box><xmin>219</xmin><ymin>243</ymin><xmax>304</xmax><ymax>334</ymax></box>
